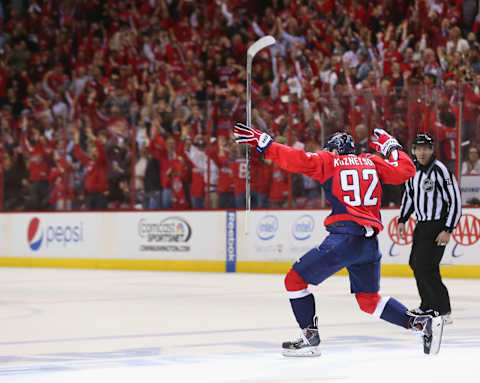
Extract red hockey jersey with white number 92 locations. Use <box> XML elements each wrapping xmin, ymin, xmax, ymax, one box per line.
<box><xmin>266</xmin><ymin>143</ymin><xmax>415</xmax><ymax>232</ymax></box>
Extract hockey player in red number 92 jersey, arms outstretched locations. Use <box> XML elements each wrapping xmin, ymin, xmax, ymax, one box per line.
<box><xmin>233</xmin><ymin>123</ymin><xmax>443</xmax><ymax>356</ymax></box>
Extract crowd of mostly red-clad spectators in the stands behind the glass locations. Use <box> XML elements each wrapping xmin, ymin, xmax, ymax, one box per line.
<box><xmin>0</xmin><ymin>0</ymin><xmax>480</xmax><ymax>210</ymax></box>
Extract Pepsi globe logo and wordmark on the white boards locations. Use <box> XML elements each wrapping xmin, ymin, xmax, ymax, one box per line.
<box><xmin>27</xmin><ymin>217</ymin><xmax>84</xmax><ymax>251</ymax></box>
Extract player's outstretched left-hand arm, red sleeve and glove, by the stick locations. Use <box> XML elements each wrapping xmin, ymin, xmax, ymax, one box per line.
<box><xmin>233</xmin><ymin>123</ymin><xmax>331</xmax><ymax>181</ymax></box>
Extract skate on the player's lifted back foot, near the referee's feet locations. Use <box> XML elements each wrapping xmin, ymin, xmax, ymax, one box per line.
<box><xmin>407</xmin><ymin>311</ymin><xmax>444</xmax><ymax>355</ymax></box>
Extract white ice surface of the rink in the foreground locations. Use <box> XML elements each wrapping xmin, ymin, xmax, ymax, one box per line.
<box><xmin>0</xmin><ymin>268</ymin><xmax>480</xmax><ymax>383</ymax></box>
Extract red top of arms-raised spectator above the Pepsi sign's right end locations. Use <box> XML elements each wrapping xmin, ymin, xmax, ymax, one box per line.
<box><xmin>74</xmin><ymin>140</ymin><xmax>108</xmax><ymax>193</ymax></box>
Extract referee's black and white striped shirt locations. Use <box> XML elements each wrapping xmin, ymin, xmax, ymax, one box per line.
<box><xmin>398</xmin><ymin>159</ymin><xmax>462</xmax><ymax>233</ymax></box>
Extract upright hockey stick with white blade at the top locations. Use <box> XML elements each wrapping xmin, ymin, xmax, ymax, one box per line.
<box><xmin>245</xmin><ymin>36</ymin><xmax>275</xmax><ymax>235</ymax></box>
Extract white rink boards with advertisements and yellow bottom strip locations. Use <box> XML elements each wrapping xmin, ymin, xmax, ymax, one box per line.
<box><xmin>0</xmin><ymin>209</ymin><xmax>480</xmax><ymax>278</ymax></box>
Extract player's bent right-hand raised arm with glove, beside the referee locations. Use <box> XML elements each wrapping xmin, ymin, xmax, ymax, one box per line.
<box><xmin>369</xmin><ymin>129</ymin><xmax>415</xmax><ymax>185</ymax></box>
